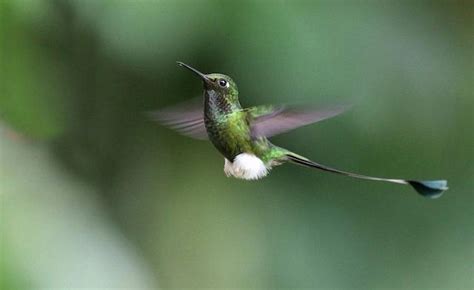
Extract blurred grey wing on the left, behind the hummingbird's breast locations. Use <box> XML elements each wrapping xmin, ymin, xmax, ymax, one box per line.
<box><xmin>149</xmin><ymin>98</ymin><xmax>208</xmax><ymax>140</ymax></box>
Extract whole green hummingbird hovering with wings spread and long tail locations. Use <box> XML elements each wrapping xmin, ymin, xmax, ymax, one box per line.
<box><xmin>151</xmin><ymin>62</ymin><xmax>448</xmax><ymax>198</ymax></box>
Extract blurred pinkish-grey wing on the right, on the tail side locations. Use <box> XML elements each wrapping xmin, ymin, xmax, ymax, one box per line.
<box><xmin>248</xmin><ymin>105</ymin><xmax>350</xmax><ymax>137</ymax></box>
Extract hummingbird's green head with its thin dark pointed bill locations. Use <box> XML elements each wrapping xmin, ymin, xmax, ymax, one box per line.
<box><xmin>177</xmin><ymin>61</ymin><xmax>238</xmax><ymax>95</ymax></box>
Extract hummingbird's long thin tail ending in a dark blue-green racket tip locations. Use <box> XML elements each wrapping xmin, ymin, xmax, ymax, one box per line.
<box><xmin>286</xmin><ymin>153</ymin><xmax>448</xmax><ymax>198</ymax></box>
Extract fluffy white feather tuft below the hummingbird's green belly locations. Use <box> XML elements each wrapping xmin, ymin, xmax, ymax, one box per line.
<box><xmin>224</xmin><ymin>153</ymin><xmax>269</xmax><ymax>180</ymax></box>
